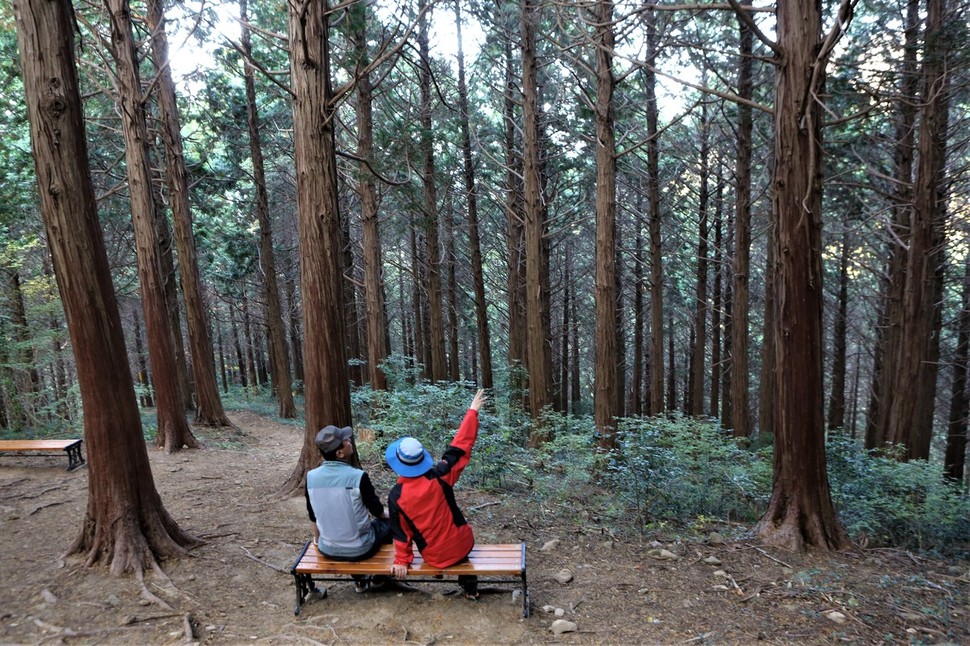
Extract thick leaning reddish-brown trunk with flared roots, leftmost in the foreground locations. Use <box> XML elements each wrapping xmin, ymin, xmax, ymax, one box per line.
<box><xmin>13</xmin><ymin>0</ymin><xmax>200</xmax><ymax>581</ymax></box>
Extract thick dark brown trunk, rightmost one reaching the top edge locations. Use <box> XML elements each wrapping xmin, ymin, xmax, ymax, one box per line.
<box><xmin>887</xmin><ymin>0</ymin><xmax>948</xmax><ymax>459</ymax></box>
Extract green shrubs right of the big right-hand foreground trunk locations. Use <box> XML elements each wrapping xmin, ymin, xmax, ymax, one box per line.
<box><xmin>827</xmin><ymin>436</ymin><xmax>970</xmax><ymax>553</ymax></box>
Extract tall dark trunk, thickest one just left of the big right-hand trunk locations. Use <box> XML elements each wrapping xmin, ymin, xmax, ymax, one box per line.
<box><xmin>731</xmin><ymin>0</ymin><xmax>752</xmax><ymax>437</ymax></box>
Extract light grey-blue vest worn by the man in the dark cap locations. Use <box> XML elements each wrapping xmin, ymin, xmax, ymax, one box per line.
<box><xmin>306</xmin><ymin>461</ymin><xmax>374</xmax><ymax>557</ymax></box>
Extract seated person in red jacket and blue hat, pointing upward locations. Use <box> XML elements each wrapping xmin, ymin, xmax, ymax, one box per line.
<box><xmin>384</xmin><ymin>390</ymin><xmax>485</xmax><ymax>599</ymax></box>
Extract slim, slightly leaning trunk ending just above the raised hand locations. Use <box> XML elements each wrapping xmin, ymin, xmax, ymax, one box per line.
<box><xmin>455</xmin><ymin>0</ymin><xmax>493</xmax><ymax>390</ymax></box>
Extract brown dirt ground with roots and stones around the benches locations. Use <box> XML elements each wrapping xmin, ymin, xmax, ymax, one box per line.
<box><xmin>0</xmin><ymin>411</ymin><xmax>970</xmax><ymax>645</ymax></box>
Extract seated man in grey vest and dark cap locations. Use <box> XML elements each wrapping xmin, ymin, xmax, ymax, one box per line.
<box><xmin>306</xmin><ymin>426</ymin><xmax>391</xmax><ymax>592</ymax></box>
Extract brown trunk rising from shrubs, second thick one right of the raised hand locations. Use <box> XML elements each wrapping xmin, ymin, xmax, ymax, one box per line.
<box><xmin>591</xmin><ymin>0</ymin><xmax>619</xmax><ymax>450</ymax></box>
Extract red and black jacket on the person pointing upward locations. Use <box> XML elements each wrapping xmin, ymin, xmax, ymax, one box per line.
<box><xmin>387</xmin><ymin>409</ymin><xmax>478</xmax><ymax>567</ymax></box>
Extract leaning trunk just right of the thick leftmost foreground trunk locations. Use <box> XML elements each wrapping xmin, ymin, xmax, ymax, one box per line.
<box><xmin>106</xmin><ymin>0</ymin><xmax>197</xmax><ymax>453</ymax></box>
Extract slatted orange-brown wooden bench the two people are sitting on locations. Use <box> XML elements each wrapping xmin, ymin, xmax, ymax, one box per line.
<box><xmin>290</xmin><ymin>541</ymin><xmax>529</xmax><ymax>617</ymax></box>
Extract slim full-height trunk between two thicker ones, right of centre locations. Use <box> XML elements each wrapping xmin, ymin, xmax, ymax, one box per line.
<box><xmin>644</xmin><ymin>11</ymin><xmax>664</xmax><ymax>415</ymax></box>
